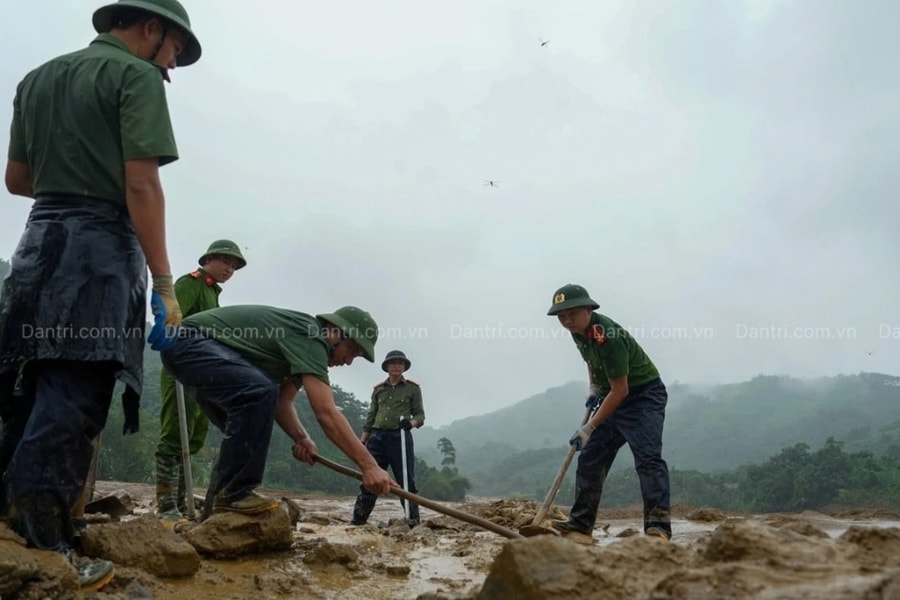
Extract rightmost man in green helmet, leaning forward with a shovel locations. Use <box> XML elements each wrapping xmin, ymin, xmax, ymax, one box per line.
<box><xmin>547</xmin><ymin>283</ymin><xmax>672</xmax><ymax>540</ymax></box>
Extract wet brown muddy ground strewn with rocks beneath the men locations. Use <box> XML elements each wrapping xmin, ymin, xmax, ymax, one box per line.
<box><xmin>0</xmin><ymin>482</ymin><xmax>900</xmax><ymax>600</ymax></box>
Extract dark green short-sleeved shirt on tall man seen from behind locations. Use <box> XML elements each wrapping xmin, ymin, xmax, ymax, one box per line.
<box><xmin>9</xmin><ymin>33</ymin><xmax>178</xmax><ymax>204</ymax></box>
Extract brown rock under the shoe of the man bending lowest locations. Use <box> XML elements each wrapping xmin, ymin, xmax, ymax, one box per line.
<box><xmin>183</xmin><ymin>509</ymin><xmax>293</xmax><ymax>558</ymax></box>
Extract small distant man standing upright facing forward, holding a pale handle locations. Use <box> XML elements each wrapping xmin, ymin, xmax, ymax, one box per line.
<box><xmin>350</xmin><ymin>350</ymin><xmax>425</xmax><ymax>527</ymax></box>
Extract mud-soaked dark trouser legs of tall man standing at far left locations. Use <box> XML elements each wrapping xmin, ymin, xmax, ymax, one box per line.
<box><xmin>4</xmin><ymin>360</ymin><xmax>121</xmax><ymax>552</ymax></box>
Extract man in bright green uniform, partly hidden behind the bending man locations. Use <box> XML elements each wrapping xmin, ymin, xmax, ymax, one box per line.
<box><xmin>156</xmin><ymin>240</ymin><xmax>247</xmax><ymax>520</ymax></box>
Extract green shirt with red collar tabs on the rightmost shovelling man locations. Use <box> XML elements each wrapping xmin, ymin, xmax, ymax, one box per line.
<box><xmin>572</xmin><ymin>313</ymin><xmax>659</xmax><ymax>395</ymax></box>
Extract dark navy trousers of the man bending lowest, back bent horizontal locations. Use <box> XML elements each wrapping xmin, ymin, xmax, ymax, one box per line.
<box><xmin>160</xmin><ymin>327</ymin><xmax>278</xmax><ymax>518</ymax></box>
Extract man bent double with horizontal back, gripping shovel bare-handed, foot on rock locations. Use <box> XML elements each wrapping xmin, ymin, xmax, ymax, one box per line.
<box><xmin>160</xmin><ymin>305</ymin><xmax>392</xmax><ymax>518</ymax></box>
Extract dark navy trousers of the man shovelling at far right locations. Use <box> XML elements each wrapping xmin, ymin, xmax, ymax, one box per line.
<box><xmin>569</xmin><ymin>381</ymin><xmax>672</xmax><ymax>537</ymax></box>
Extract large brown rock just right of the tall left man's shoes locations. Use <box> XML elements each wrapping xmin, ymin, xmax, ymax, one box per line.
<box><xmin>81</xmin><ymin>515</ymin><xmax>200</xmax><ymax>577</ymax></box>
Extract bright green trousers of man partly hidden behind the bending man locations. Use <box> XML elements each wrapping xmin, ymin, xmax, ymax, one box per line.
<box><xmin>156</xmin><ymin>369</ymin><xmax>209</xmax><ymax>514</ymax></box>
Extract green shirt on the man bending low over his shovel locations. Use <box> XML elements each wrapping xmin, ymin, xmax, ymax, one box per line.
<box><xmin>183</xmin><ymin>304</ymin><xmax>330</xmax><ymax>387</ymax></box>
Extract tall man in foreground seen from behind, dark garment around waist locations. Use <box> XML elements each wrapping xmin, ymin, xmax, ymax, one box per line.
<box><xmin>0</xmin><ymin>0</ymin><xmax>200</xmax><ymax>589</ymax></box>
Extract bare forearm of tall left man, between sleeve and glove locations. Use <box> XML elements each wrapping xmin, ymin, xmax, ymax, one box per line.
<box><xmin>125</xmin><ymin>161</ymin><xmax>172</xmax><ymax>275</ymax></box>
